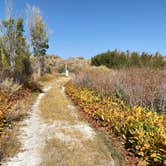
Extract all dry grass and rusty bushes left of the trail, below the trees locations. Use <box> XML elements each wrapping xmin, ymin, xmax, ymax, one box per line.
<box><xmin>0</xmin><ymin>71</ymin><xmax>56</xmax><ymax>161</ymax></box>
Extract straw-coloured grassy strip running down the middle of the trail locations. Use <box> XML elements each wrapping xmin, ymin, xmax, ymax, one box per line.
<box><xmin>40</xmin><ymin>78</ymin><xmax>123</xmax><ymax>166</ymax></box>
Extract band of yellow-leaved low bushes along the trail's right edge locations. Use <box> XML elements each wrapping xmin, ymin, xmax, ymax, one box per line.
<box><xmin>66</xmin><ymin>83</ymin><xmax>166</xmax><ymax>166</ymax></box>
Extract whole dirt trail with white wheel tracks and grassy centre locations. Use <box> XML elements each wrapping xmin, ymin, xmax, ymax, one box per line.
<box><xmin>2</xmin><ymin>78</ymin><xmax>115</xmax><ymax>166</ymax></box>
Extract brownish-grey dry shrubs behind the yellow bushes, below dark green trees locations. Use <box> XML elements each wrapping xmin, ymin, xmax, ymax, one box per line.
<box><xmin>73</xmin><ymin>68</ymin><xmax>166</xmax><ymax>113</ymax></box>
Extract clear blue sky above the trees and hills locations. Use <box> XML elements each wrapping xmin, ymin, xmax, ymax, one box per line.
<box><xmin>0</xmin><ymin>0</ymin><xmax>166</xmax><ymax>58</ymax></box>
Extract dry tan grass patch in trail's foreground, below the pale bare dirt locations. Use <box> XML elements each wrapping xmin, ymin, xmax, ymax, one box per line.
<box><xmin>41</xmin><ymin>138</ymin><xmax>115</xmax><ymax>166</ymax></box>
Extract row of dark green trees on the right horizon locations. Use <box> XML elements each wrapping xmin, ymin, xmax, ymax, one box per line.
<box><xmin>91</xmin><ymin>50</ymin><xmax>166</xmax><ymax>69</ymax></box>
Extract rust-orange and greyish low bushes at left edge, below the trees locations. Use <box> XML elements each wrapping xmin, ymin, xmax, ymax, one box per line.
<box><xmin>0</xmin><ymin>78</ymin><xmax>34</xmax><ymax>136</ymax></box>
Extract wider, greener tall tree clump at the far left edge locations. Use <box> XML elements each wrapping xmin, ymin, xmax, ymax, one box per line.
<box><xmin>0</xmin><ymin>14</ymin><xmax>30</xmax><ymax>79</ymax></box>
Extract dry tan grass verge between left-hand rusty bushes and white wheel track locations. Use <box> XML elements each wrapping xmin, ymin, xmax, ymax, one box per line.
<box><xmin>0</xmin><ymin>94</ymin><xmax>37</xmax><ymax>161</ymax></box>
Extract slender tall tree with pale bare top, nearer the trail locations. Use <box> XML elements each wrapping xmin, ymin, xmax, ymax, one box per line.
<box><xmin>27</xmin><ymin>6</ymin><xmax>49</xmax><ymax>77</ymax></box>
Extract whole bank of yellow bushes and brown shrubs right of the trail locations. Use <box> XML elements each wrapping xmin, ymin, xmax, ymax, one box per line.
<box><xmin>66</xmin><ymin>67</ymin><xmax>166</xmax><ymax>165</ymax></box>
